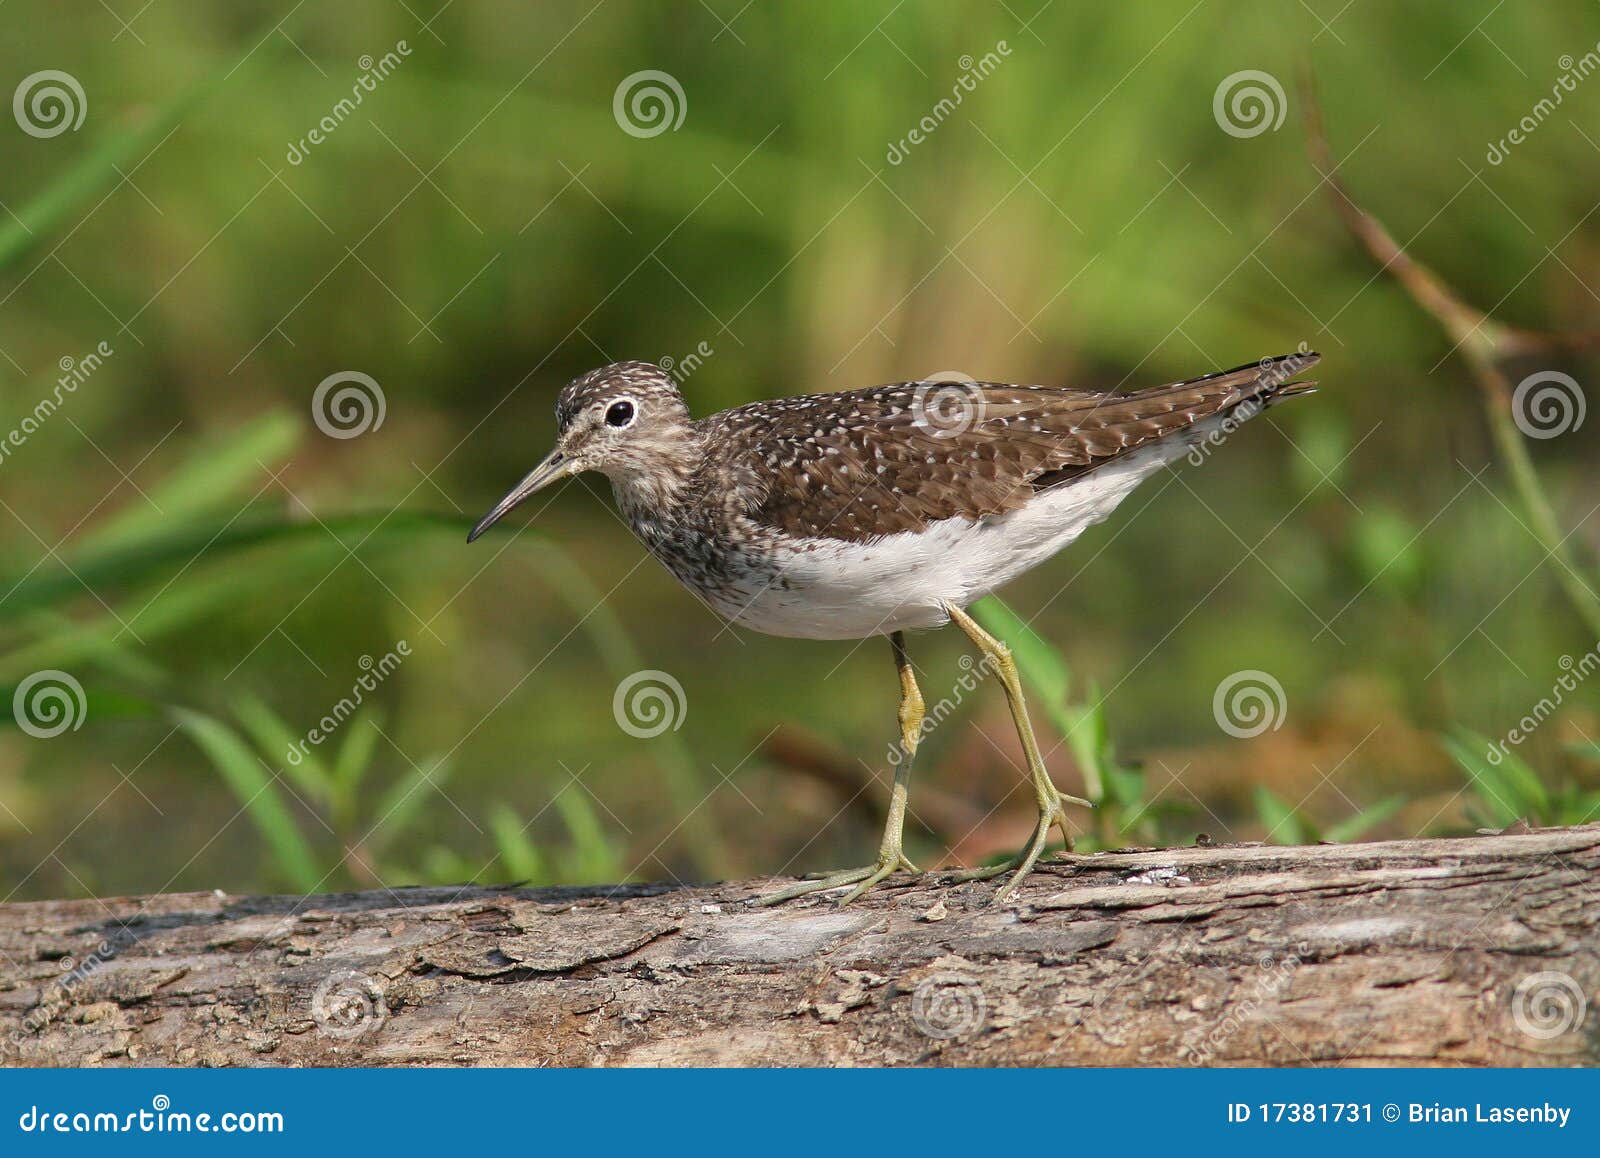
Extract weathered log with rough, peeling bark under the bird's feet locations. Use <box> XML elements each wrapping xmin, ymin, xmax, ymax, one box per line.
<box><xmin>0</xmin><ymin>825</ymin><xmax>1600</xmax><ymax>1065</ymax></box>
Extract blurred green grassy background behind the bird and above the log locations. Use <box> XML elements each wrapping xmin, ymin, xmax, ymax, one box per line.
<box><xmin>0</xmin><ymin>0</ymin><xmax>1600</xmax><ymax>899</ymax></box>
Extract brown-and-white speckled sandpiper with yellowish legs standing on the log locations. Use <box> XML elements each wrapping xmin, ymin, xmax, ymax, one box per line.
<box><xmin>467</xmin><ymin>347</ymin><xmax>1320</xmax><ymax>904</ymax></box>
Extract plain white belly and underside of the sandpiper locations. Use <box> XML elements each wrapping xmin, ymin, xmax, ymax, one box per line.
<box><xmin>712</xmin><ymin>440</ymin><xmax>1187</xmax><ymax>640</ymax></box>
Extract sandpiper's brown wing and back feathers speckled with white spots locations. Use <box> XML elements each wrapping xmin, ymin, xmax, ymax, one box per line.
<box><xmin>702</xmin><ymin>353</ymin><xmax>1317</xmax><ymax>542</ymax></box>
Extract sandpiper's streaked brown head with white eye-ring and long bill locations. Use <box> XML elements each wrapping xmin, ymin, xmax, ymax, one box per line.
<box><xmin>467</xmin><ymin>361</ymin><xmax>694</xmax><ymax>542</ymax></box>
